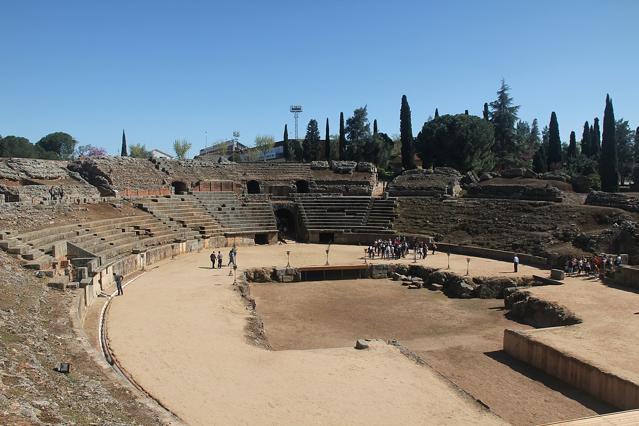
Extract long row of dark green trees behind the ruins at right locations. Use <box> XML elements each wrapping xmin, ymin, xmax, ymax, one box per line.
<box><xmin>283</xmin><ymin>80</ymin><xmax>639</xmax><ymax>192</ymax></box>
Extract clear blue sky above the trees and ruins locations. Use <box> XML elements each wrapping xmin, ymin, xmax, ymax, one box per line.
<box><xmin>0</xmin><ymin>0</ymin><xmax>639</xmax><ymax>156</ymax></box>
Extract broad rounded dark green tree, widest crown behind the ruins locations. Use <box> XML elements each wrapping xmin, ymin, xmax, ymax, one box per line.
<box><xmin>415</xmin><ymin>114</ymin><xmax>495</xmax><ymax>172</ymax></box>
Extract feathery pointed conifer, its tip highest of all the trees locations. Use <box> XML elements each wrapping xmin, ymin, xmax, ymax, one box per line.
<box><xmin>489</xmin><ymin>79</ymin><xmax>519</xmax><ymax>167</ymax></box>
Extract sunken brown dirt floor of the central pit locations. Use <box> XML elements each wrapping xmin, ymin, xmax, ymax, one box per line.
<box><xmin>251</xmin><ymin>280</ymin><xmax>613</xmax><ymax>425</ymax></box>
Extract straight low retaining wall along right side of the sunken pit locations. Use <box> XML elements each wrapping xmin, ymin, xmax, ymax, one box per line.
<box><xmin>504</xmin><ymin>329</ymin><xmax>639</xmax><ymax>410</ymax></box>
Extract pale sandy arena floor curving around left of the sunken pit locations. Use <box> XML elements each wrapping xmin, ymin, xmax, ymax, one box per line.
<box><xmin>107</xmin><ymin>245</ymin><xmax>512</xmax><ymax>425</ymax></box>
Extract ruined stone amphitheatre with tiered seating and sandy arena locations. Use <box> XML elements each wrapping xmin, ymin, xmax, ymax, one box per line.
<box><xmin>0</xmin><ymin>157</ymin><xmax>639</xmax><ymax>425</ymax></box>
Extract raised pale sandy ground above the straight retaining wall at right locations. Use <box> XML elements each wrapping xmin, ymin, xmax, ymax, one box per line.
<box><xmin>516</xmin><ymin>277</ymin><xmax>639</xmax><ymax>383</ymax></box>
